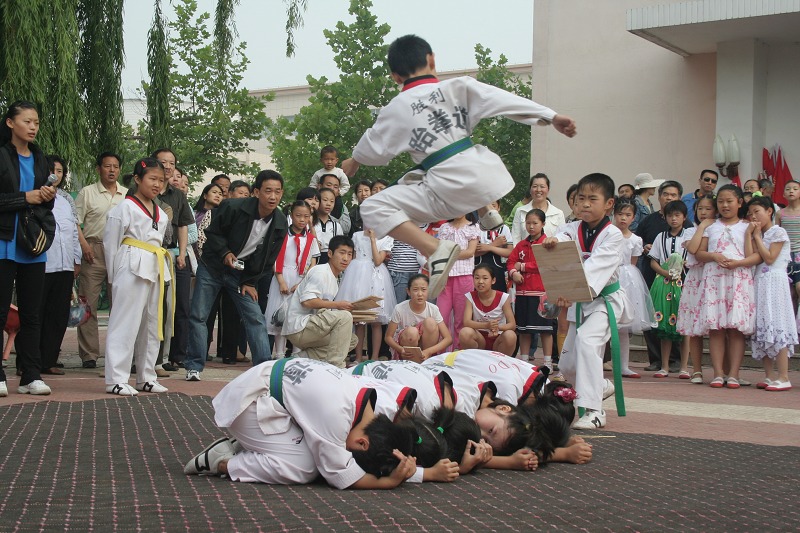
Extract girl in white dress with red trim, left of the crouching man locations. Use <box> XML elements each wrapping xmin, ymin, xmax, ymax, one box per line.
<box><xmin>264</xmin><ymin>200</ymin><xmax>319</xmax><ymax>358</ymax></box>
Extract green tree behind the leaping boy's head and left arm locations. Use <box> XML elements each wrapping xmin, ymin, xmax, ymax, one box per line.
<box><xmin>267</xmin><ymin>0</ymin><xmax>411</xmax><ymax>197</ymax></box>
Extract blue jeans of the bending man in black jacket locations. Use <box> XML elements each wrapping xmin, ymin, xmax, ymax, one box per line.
<box><xmin>183</xmin><ymin>263</ymin><xmax>272</xmax><ymax>371</ymax></box>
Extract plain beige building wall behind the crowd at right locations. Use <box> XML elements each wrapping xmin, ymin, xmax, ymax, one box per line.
<box><xmin>531</xmin><ymin>0</ymin><xmax>716</xmax><ymax>211</ymax></box>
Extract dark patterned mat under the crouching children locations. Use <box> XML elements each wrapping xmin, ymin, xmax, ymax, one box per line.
<box><xmin>0</xmin><ymin>393</ymin><xmax>800</xmax><ymax>532</ymax></box>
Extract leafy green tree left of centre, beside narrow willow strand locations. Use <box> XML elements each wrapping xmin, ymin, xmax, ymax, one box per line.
<box><xmin>169</xmin><ymin>0</ymin><xmax>267</xmax><ymax>179</ymax></box>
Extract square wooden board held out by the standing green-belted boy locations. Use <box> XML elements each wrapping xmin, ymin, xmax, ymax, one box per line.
<box><xmin>533</xmin><ymin>241</ymin><xmax>593</xmax><ymax>303</ymax></box>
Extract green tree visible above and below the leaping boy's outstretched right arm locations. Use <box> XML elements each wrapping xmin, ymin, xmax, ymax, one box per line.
<box><xmin>472</xmin><ymin>44</ymin><xmax>531</xmax><ymax>213</ymax></box>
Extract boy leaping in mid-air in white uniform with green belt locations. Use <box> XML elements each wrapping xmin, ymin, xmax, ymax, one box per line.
<box><xmin>342</xmin><ymin>35</ymin><xmax>575</xmax><ymax>297</ymax></box>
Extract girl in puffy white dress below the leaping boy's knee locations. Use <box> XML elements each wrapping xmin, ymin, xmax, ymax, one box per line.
<box><xmin>336</xmin><ymin>229</ymin><xmax>396</xmax><ymax>362</ymax></box>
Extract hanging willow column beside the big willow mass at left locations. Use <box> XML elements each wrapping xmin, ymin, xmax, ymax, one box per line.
<box><xmin>79</xmin><ymin>0</ymin><xmax>125</xmax><ymax>164</ymax></box>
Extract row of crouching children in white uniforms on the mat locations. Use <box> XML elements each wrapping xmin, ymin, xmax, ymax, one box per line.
<box><xmin>184</xmin><ymin>350</ymin><xmax>592</xmax><ymax>489</ymax></box>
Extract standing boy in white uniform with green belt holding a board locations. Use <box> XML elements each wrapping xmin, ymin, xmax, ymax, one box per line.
<box><xmin>542</xmin><ymin>173</ymin><xmax>631</xmax><ymax>429</ymax></box>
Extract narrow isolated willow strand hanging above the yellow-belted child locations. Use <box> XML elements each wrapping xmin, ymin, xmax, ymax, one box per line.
<box><xmin>144</xmin><ymin>0</ymin><xmax>172</xmax><ymax>152</ymax></box>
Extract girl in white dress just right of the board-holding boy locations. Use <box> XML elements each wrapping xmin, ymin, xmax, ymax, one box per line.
<box><xmin>614</xmin><ymin>198</ymin><xmax>656</xmax><ymax>378</ymax></box>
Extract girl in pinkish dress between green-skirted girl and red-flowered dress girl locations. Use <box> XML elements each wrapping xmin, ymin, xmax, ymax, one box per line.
<box><xmin>675</xmin><ymin>195</ymin><xmax>717</xmax><ymax>385</ymax></box>
